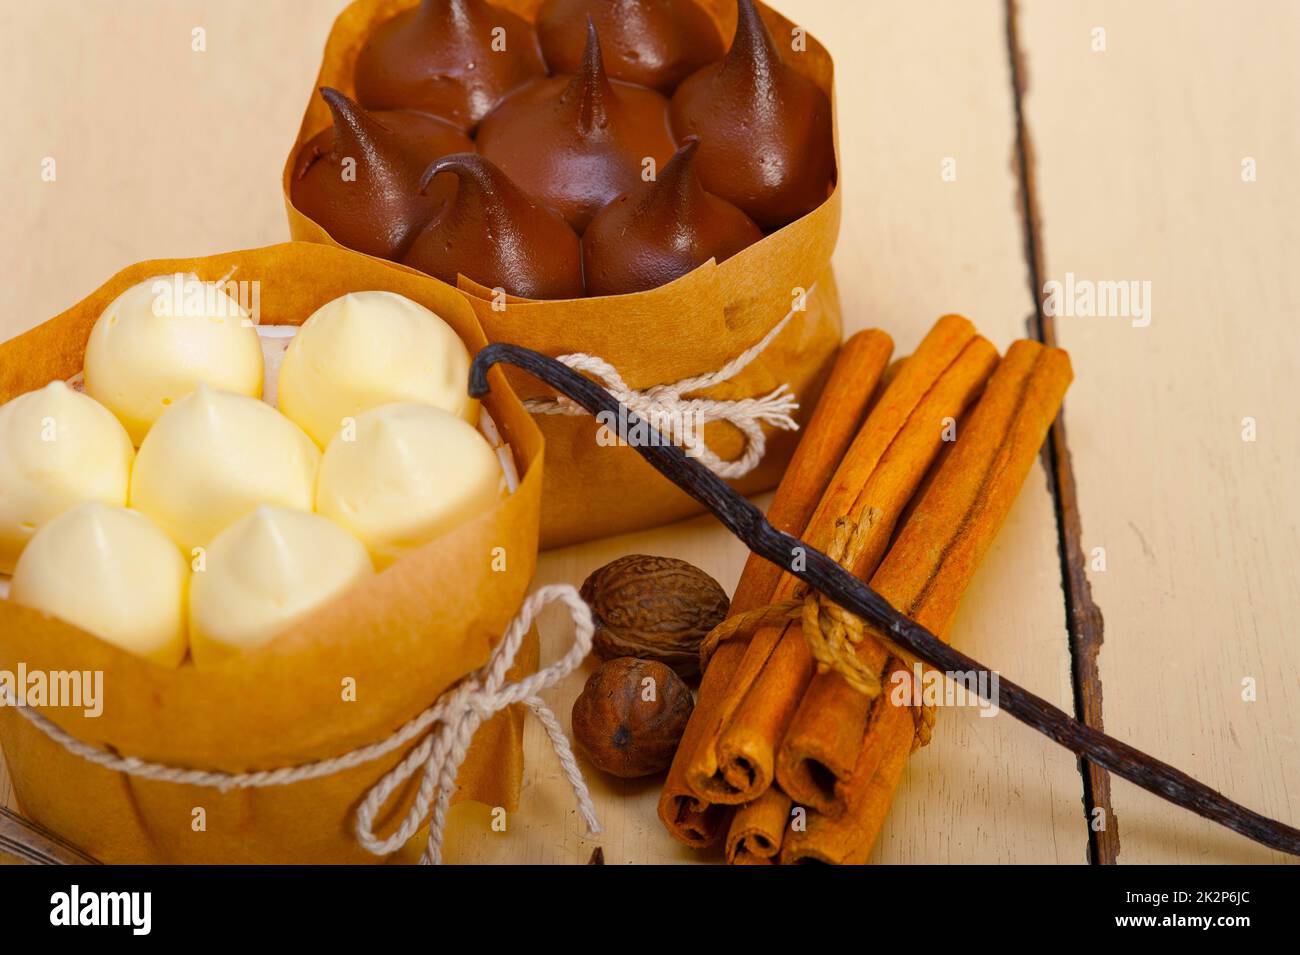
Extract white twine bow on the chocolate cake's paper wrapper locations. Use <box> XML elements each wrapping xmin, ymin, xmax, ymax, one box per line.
<box><xmin>524</xmin><ymin>288</ymin><xmax>813</xmax><ymax>478</ymax></box>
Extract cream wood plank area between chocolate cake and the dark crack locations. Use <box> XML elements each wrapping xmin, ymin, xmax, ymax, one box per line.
<box><xmin>800</xmin><ymin>0</ymin><xmax>1087</xmax><ymax>863</ymax></box>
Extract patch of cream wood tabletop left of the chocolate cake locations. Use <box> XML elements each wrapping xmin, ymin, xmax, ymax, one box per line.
<box><xmin>0</xmin><ymin>0</ymin><xmax>346</xmax><ymax>338</ymax></box>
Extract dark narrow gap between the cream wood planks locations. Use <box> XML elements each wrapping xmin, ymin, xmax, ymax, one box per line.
<box><xmin>1005</xmin><ymin>0</ymin><xmax>1119</xmax><ymax>865</ymax></box>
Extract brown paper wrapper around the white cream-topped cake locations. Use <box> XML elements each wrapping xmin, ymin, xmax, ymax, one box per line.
<box><xmin>0</xmin><ymin>243</ymin><xmax>542</xmax><ymax>863</ymax></box>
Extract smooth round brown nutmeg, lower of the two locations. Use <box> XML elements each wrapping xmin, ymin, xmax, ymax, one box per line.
<box><xmin>572</xmin><ymin>656</ymin><xmax>696</xmax><ymax>778</ymax></box>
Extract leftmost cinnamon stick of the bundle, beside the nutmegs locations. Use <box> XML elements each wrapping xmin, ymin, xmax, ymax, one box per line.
<box><xmin>659</xmin><ymin>330</ymin><xmax>893</xmax><ymax>848</ymax></box>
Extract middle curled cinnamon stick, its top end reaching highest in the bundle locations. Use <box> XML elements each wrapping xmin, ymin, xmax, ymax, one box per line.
<box><xmin>688</xmin><ymin>316</ymin><xmax>997</xmax><ymax>803</ymax></box>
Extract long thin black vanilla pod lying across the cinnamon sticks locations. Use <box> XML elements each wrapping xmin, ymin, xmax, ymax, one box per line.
<box><xmin>469</xmin><ymin>343</ymin><xmax>1300</xmax><ymax>855</ymax></box>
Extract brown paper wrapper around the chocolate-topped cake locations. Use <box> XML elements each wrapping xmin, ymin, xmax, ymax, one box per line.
<box><xmin>282</xmin><ymin>0</ymin><xmax>841</xmax><ymax>547</ymax></box>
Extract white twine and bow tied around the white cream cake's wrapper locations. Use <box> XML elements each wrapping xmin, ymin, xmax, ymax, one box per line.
<box><xmin>17</xmin><ymin>583</ymin><xmax>602</xmax><ymax>865</ymax></box>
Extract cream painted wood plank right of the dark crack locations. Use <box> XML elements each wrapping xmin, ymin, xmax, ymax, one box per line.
<box><xmin>1021</xmin><ymin>0</ymin><xmax>1300</xmax><ymax>863</ymax></box>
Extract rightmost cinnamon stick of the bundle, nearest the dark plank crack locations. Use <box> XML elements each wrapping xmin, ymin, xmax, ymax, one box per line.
<box><xmin>781</xmin><ymin>342</ymin><xmax>1073</xmax><ymax>863</ymax></box>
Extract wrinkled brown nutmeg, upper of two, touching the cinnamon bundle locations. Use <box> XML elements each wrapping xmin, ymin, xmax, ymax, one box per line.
<box><xmin>581</xmin><ymin>554</ymin><xmax>731</xmax><ymax>680</ymax></box>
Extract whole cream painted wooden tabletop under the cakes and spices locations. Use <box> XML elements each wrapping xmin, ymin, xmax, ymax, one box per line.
<box><xmin>0</xmin><ymin>0</ymin><xmax>1300</xmax><ymax>863</ymax></box>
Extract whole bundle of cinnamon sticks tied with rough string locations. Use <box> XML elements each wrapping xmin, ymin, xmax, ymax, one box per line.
<box><xmin>659</xmin><ymin>316</ymin><xmax>1071</xmax><ymax>864</ymax></box>
